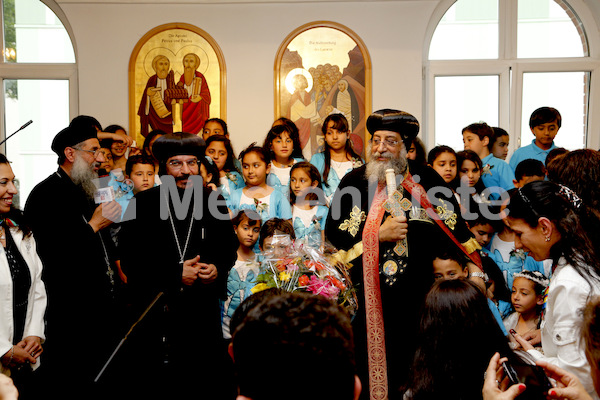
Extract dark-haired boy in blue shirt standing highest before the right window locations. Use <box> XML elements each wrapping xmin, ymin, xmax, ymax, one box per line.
<box><xmin>509</xmin><ymin>107</ymin><xmax>562</xmax><ymax>171</ymax></box>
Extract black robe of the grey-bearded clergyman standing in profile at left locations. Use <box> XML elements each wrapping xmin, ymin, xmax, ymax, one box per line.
<box><xmin>25</xmin><ymin>168</ymin><xmax>121</xmax><ymax>398</ymax></box>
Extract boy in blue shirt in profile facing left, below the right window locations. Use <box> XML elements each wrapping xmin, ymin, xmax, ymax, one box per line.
<box><xmin>462</xmin><ymin>122</ymin><xmax>515</xmax><ymax>199</ymax></box>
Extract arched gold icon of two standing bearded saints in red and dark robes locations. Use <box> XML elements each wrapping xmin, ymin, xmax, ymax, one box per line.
<box><xmin>129</xmin><ymin>23</ymin><xmax>226</xmax><ymax>147</ymax></box>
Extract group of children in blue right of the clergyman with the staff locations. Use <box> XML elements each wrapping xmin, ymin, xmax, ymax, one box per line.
<box><xmin>427</xmin><ymin>107</ymin><xmax>567</xmax><ymax>348</ymax></box>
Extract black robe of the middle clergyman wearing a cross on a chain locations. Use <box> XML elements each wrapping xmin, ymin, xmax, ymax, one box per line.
<box><xmin>119</xmin><ymin>184</ymin><xmax>238</xmax><ymax>399</ymax></box>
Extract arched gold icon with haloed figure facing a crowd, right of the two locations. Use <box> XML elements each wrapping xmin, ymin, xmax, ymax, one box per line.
<box><xmin>275</xmin><ymin>21</ymin><xmax>371</xmax><ymax>158</ymax></box>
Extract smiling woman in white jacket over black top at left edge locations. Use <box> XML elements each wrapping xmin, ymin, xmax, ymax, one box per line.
<box><xmin>0</xmin><ymin>154</ymin><xmax>46</xmax><ymax>398</ymax></box>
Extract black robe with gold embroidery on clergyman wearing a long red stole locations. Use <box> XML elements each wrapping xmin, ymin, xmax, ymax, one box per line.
<box><xmin>325</xmin><ymin>163</ymin><xmax>472</xmax><ymax>399</ymax></box>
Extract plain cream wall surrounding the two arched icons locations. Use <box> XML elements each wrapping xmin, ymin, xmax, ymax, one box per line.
<box><xmin>58</xmin><ymin>0</ymin><xmax>439</xmax><ymax>151</ymax></box>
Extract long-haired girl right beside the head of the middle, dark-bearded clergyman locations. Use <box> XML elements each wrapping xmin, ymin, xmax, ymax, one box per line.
<box><xmin>206</xmin><ymin>135</ymin><xmax>245</xmax><ymax>200</ymax></box>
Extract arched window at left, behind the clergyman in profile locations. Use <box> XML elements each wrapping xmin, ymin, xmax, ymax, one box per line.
<box><xmin>0</xmin><ymin>0</ymin><xmax>77</xmax><ymax>207</ymax></box>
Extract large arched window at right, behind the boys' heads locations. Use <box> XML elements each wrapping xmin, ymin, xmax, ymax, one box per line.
<box><xmin>425</xmin><ymin>0</ymin><xmax>600</xmax><ymax>157</ymax></box>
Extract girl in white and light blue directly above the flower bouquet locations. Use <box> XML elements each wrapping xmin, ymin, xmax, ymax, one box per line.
<box><xmin>290</xmin><ymin>161</ymin><xmax>329</xmax><ymax>246</ymax></box>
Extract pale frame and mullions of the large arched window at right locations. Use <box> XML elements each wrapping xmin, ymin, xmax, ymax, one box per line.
<box><xmin>423</xmin><ymin>0</ymin><xmax>600</xmax><ymax>157</ymax></box>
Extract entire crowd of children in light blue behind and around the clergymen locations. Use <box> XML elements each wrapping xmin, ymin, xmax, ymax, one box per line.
<box><xmin>94</xmin><ymin>107</ymin><xmax>584</xmax><ymax>394</ymax></box>
